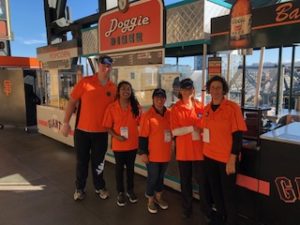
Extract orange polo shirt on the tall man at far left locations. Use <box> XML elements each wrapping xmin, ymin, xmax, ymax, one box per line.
<box><xmin>71</xmin><ymin>74</ymin><xmax>116</xmax><ymax>132</ymax></box>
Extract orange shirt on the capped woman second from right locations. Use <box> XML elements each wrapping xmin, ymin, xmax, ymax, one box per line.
<box><xmin>171</xmin><ymin>100</ymin><xmax>203</xmax><ymax>161</ymax></box>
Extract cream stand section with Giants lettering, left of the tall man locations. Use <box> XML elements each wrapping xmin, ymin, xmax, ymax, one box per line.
<box><xmin>37</xmin><ymin>39</ymin><xmax>82</xmax><ymax>146</ymax></box>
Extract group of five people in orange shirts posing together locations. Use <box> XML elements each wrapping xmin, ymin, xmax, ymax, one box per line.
<box><xmin>62</xmin><ymin>56</ymin><xmax>246</xmax><ymax>225</ymax></box>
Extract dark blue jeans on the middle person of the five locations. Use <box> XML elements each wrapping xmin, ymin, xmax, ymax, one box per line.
<box><xmin>146</xmin><ymin>162</ymin><xmax>168</xmax><ymax>197</ymax></box>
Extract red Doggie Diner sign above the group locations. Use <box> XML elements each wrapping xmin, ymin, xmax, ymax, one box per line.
<box><xmin>98</xmin><ymin>0</ymin><xmax>163</xmax><ymax>53</ymax></box>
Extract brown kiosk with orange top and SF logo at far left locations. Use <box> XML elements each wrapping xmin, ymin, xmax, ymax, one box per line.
<box><xmin>0</xmin><ymin>56</ymin><xmax>42</xmax><ymax>130</ymax></box>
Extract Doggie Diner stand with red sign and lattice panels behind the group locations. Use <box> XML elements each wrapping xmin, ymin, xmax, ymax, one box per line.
<box><xmin>82</xmin><ymin>0</ymin><xmax>229</xmax><ymax>195</ymax></box>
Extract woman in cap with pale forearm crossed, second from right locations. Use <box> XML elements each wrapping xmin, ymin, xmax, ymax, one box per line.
<box><xmin>171</xmin><ymin>78</ymin><xmax>210</xmax><ymax>218</ymax></box>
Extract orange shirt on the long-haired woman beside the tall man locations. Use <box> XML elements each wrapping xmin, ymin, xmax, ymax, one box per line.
<box><xmin>103</xmin><ymin>100</ymin><xmax>139</xmax><ymax>151</ymax></box>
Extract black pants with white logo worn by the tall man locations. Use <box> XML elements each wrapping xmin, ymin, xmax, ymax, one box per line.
<box><xmin>74</xmin><ymin>129</ymin><xmax>108</xmax><ymax>190</ymax></box>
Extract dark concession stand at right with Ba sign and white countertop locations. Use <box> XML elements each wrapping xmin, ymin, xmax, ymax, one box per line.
<box><xmin>211</xmin><ymin>0</ymin><xmax>300</xmax><ymax>225</ymax></box>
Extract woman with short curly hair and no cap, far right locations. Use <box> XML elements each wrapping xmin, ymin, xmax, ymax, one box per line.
<box><xmin>202</xmin><ymin>76</ymin><xmax>247</xmax><ymax>225</ymax></box>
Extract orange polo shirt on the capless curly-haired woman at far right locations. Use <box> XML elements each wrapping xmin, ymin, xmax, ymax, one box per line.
<box><xmin>202</xmin><ymin>99</ymin><xmax>247</xmax><ymax>163</ymax></box>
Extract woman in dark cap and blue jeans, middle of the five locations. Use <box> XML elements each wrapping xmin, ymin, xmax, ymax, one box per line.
<box><xmin>139</xmin><ymin>88</ymin><xmax>172</xmax><ymax>213</ymax></box>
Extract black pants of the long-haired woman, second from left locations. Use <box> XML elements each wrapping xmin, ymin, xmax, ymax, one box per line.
<box><xmin>114</xmin><ymin>150</ymin><xmax>137</xmax><ymax>193</ymax></box>
